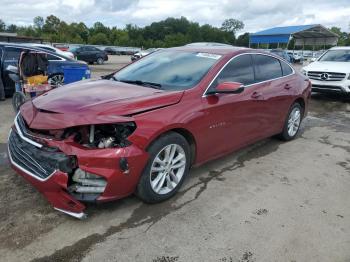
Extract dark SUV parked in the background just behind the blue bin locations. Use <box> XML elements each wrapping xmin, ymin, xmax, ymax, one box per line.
<box><xmin>69</xmin><ymin>46</ymin><xmax>108</xmax><ymax>65</ymax></box>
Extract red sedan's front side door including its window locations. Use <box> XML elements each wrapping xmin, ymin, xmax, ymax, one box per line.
<box><xmin>199</xmin><ymin>54</ymin><xmax>265</xmax><ymax>161</ymax></box>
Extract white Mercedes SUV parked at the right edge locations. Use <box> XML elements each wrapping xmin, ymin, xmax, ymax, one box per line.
<box><xmin>302</xmin><ymin>47</ymin><xmax>350</xmax><ymax>94</ymax></box>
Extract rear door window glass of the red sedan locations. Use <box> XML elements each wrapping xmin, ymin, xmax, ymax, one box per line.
<box><xmin>254</xmin><ymin>55</ymin><xmax>282</xmax><ymax>82</ymax></box>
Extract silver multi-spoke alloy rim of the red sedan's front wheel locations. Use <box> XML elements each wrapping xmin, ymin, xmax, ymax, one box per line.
<box><xmin>150</xmin><ymin>144</ymin><xmax>187</xmax><ymax>195</ymax></box>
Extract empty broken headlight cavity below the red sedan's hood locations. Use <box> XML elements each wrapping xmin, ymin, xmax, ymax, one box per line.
<box><xmin>84</xmin><ymin>122</ymin><xmax>136</xmax><ymax>148</ymax></box>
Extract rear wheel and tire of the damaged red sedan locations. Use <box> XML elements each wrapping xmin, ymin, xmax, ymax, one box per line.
<box><xmin>279</xmin><ymin>103</ymin><xmax>304</xmax><ymax>141</ymax></box>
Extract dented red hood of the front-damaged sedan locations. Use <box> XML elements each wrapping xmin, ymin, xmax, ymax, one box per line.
<box><xmin>21</xmin><ymin>80</ymin><xmax>183</xmax><ymax>129</ymax></box>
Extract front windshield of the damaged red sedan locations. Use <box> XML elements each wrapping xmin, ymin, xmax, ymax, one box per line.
<box><xmin>113</xmin><ymin>50</ymin><xmax>221</xmax><ymax>90</ymax></box>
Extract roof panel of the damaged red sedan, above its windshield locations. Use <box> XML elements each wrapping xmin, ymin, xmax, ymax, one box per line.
<box><xmin>169</xmin><ymin>45</ymin><xmax>249</xmax><ymax>55</ymax></box>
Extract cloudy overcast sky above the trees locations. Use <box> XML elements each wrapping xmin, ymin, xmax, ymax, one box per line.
<box><xmin>0</xmin><ymin>0</ymin><xmax>350</xmax><ymax>32</ymax></box>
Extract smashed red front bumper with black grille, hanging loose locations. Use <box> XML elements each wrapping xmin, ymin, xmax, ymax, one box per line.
<box><xmin>8</xmin><ymin>116</ymin><xmax>148</xmax><ymax>219</ymax></box>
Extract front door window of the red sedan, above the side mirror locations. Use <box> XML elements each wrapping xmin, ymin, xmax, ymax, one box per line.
<box><xmin>213</xmin><ymin>55</ymin><xmax>254</xmax><ymax>87</ymax></box>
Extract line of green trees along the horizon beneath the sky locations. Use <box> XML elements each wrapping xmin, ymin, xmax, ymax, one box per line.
<box><xmin>0</xmin><ymin>15</ymin><xmax>350</xmax><ymax>49</ymax></box>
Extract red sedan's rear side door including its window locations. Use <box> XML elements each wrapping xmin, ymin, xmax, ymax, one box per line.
<box><xmin>253</xmin><ymin>54</ymin><xmax>295</xmax><ymax>137</ymax></box>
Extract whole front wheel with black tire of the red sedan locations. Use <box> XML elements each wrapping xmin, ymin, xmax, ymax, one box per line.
<box><xmin>136</xmin><ymin>132</ymin><xmax>191</xmax><ymax>203</ymax></box>
